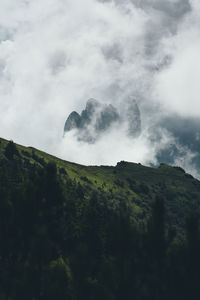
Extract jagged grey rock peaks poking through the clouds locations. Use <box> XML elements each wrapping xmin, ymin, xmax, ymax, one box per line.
<box><xmin>64</xmin><ymin>99</ymin><xmax>141</xmax><ymax>143</ymax></box>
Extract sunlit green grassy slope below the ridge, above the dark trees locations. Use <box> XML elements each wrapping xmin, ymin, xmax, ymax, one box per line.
<box><xmin>0</xmin><ymin>139</ymin><xmax>200</xmax><ymax>236</ymax></box>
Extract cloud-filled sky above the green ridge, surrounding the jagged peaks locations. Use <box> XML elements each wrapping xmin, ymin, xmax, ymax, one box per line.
<box><xmin>0</xmin><ymin>0</ymin><xmax>200</xmax><ymax>177</ymax></box>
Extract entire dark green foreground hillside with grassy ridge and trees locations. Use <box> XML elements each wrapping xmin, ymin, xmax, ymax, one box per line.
<box><xmin>0</xmin><ymin>139</ymin><xmax>200</xmax><ymax>300</ymax></box>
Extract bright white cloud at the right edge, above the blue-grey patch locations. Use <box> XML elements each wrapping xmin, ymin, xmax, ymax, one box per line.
<box><xmin>154</xmin><ymin>16</ymin><xmax>200</xmax><ymax>117</ymax></box>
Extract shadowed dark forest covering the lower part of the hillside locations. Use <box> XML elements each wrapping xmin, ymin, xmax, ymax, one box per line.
<box><xmin>0</xmin><ymin>144</ymin><xmax>200</xmax><ymax>300</ymax></box>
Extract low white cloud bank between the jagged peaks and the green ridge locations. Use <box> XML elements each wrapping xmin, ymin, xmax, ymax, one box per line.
<box><xmin>60</xmin><ymin>128</ymin><xmax>156</xmax><ymax>165</ymax></box>
